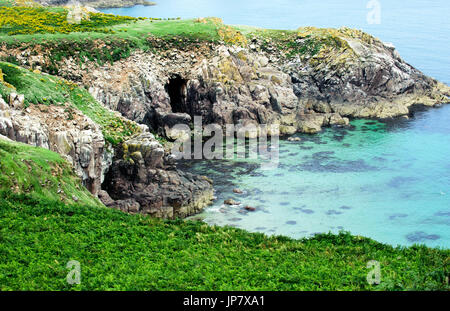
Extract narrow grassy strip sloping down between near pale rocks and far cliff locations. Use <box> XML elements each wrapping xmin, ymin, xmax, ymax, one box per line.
<box><xmin>0</xmin><ymin>62</ymin><xmax>139</xmax><ymax>145</ymax></box>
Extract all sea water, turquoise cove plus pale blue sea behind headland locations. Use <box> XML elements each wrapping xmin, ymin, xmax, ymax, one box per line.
<box><xmin>105</xmin><ymin>0</ymin><xmax>450</xmax><ymax>248</ymax></box>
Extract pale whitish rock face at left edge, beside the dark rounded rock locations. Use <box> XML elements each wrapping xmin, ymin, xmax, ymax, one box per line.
<box><xmin>0</xmin><ymin>93</ymin><xmax>108</xmax><ymax>195</ymax></box>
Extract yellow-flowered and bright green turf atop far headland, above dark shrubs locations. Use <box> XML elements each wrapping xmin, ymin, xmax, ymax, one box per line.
<box><xmin>0</xmin><ymin>7</ymin><xmax>227</xmax><ymax>43</ymax></box>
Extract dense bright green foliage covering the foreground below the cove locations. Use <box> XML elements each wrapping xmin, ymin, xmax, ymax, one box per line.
<box><xmin>0</xmin><ymin>189</ymin><xmax>450</xmax><ymax>290</ymax></box>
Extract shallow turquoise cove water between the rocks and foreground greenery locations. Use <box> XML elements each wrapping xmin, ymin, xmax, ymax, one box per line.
<box><xmin>183</xmin><ymin>105</ymin><xmax>450</xmax><ymax>247</ymax></box>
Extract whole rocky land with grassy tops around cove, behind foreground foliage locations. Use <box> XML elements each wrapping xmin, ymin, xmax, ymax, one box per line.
<box><xmin>0</xmin><ymin>1</ymin><xmax>450</xmax><ymax>288</ymax></box>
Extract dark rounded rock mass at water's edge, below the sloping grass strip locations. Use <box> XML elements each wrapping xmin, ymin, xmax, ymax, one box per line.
<box><xmin>100</xmin><ymin>132</ymin><xmax>213</xmax><ymax>219</ymax></box>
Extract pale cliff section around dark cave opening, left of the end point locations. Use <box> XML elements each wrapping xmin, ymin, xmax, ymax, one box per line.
<box><xmin>56</xmin><ymin>46</ymin><xmax>310</xmax><ymax>137</ymax></box>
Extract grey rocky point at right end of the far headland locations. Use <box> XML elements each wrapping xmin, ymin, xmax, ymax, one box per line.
<box><xmin>280</xmin><ymin>28</ymin><xmax>450</xmax><ymax>118</ymax></box>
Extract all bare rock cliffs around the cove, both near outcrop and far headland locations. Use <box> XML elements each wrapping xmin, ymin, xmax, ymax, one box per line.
<box><xmin>0</xmin><ymin>28</ymin><xmax>450</xmax><ymax>218</ymax></box>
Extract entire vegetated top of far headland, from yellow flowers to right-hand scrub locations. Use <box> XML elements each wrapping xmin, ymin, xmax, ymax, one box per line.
<box><xmin>0</xmin><ymin>7</ymin><xmax>362</xmax><ymax>70</ymax></box>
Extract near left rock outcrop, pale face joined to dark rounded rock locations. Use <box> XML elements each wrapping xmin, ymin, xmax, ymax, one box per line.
<box><xmin>0</xmin><ymin>93</ymin><xmax>213</xmax><ymax>218</ymax></box>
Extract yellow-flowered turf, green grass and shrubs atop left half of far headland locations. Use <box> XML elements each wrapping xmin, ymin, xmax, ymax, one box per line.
<box><xmin>0</xmin><ymin>7</ymin><xmax>246</xmax><ymax>67</ymax></box>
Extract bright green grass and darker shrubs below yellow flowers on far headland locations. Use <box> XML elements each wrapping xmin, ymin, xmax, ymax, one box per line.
<box><xmin>0</xmin><ymin>20</ymin><xmax>225</xmax><ymax>70</ymax></box>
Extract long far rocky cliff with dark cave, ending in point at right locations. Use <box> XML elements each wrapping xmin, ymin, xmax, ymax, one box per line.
<box><xmin>9</xmin><ymin>28</ymin><xmax>449</xmax><ymax>138</ymax></box>
